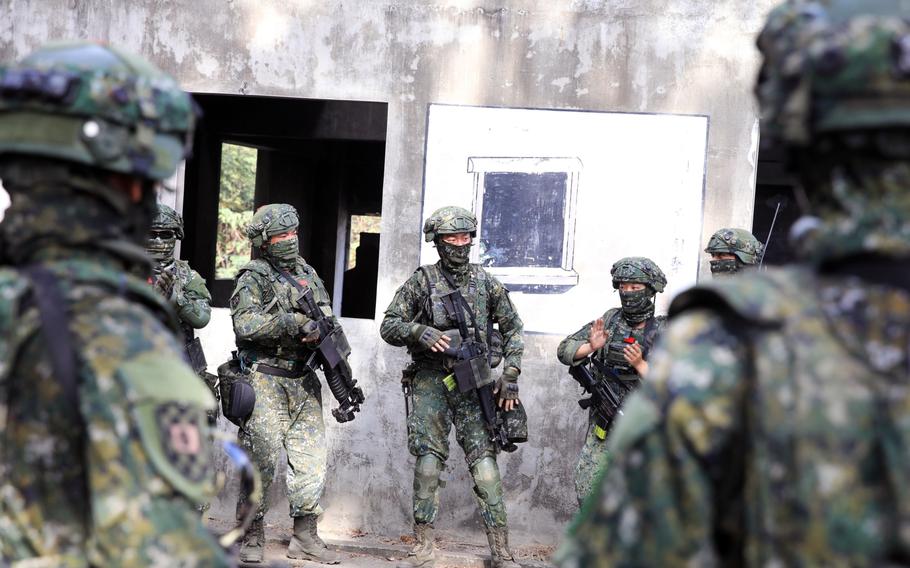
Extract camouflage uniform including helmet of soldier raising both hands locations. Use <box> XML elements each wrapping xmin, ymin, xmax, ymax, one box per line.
<box><xmin>556</xmin><ymin>257</ymin><xmax>667</xmax><ymax>503</ymax></box>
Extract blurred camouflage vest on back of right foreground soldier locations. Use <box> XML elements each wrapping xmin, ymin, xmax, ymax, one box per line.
<box><xmin>670</xmin><ymin>268</ymin><xmax>910</xmax><ymax>566</ymax></box>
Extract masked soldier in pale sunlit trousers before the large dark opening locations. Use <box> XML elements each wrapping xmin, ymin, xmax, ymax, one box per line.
<box><xmin>231</xmin><ymin>203</ymin><xmax>340</xmax><ymax>564</ymax></box>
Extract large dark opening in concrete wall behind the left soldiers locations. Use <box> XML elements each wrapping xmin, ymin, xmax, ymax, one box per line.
<box><xmin>181</xmin><ymin>94</ymin><xmax>388</xmax><ymax>318</ymax></box>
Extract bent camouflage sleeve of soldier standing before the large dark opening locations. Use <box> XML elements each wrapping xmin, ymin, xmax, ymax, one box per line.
<box><xmin>231</xmin><ymin>270</ymin><xmax>298</xmax><ymax>343</ymax></box>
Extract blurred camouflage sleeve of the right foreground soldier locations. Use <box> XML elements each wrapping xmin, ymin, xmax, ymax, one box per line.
<box><xmin>555</xmin><ymin>312</ymin><xmax>748</xmax><ymax>568</ymax></box>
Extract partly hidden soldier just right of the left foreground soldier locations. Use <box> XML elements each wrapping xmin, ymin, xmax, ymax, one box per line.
<box><xmin>145</xmin><ymin>203</ymin><xmax>218</xmax><ymax>424</ymax></box>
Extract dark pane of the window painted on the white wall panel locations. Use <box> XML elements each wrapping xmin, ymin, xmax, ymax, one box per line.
<box><xmin>480</xmin><ymin>172</ymin><xmax>567</xmax><ymax>268</ymax></box>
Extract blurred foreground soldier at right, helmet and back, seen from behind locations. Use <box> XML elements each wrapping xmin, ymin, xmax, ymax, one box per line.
<box><xmin>558</xmin><ymin>0</ymin><xmax>910</xmax><ymax>566</ymax></box>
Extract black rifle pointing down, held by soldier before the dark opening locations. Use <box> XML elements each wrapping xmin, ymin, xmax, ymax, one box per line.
<box><xmin>298</xmin><ymin>288</ymin><xmax>364</xmax><ymax>422</ymax></box>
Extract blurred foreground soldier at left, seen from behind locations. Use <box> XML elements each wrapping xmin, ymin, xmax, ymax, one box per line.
<box><xmin>0</xmin><ymin>43</ymin><xmax>229</xmax><ymax>567</ymax></box>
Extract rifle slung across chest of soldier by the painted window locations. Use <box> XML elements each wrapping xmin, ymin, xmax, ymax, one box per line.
<box><xmin>440</xmin><ymin>270</ymin><xmax>518</xmax><ymax>452</ymax></box>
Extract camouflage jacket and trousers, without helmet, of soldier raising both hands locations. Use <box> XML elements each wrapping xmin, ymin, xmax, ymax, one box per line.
<box><xmin>556</xmin><ymin>308</ymin><xmax>667</xmax><ymax>503</ymax></box>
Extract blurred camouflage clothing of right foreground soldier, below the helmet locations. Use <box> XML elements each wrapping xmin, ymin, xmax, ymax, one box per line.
<box><xmin>556</xmin><ymin>268</ymin><xmax>910</xmax><ymax>567</ymax></box>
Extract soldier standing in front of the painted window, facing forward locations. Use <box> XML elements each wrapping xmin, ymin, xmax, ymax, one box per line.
<box><xmin>380</xmin><ymin>207</ymin><xmax>524</xmax><ymax>567</ymax></box>
